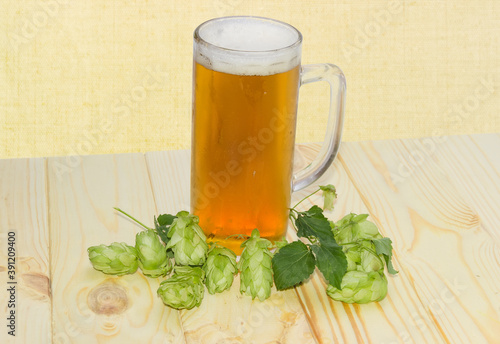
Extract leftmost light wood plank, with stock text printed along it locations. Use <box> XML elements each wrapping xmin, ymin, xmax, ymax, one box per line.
<box><xmin>0</xmin><ymin>159</ymin><xmax>52</xmax><ymax>343</ymax></box>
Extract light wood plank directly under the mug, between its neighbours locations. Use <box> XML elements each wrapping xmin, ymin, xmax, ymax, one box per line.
<box><xmin>146</xmin><ymin>151</ymin><xmax>315</xmax><ymax>344</ymax></box>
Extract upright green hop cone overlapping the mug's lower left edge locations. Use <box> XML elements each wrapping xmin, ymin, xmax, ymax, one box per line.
<box><xmin>167</xmin><ymin>211</ymin><xmax>208</xmax><ymax>265</ymax></box>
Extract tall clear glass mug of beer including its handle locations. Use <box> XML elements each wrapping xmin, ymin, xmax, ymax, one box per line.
<box><xmin>191</xmin><ymin>16</ymin><xmax>345</xmax><ymax>254</ymax></box>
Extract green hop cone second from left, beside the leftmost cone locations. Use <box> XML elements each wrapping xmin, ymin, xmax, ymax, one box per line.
<box><xmin>135</xmin><ymin>229</ymin><xmax>172</xmax><ymax>277</ymax></box>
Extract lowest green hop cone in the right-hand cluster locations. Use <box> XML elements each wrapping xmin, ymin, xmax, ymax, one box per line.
<box><xmin>326</xmin><ymin>270</ymin><xmax>387</xmax><ymax>303</ymax></box>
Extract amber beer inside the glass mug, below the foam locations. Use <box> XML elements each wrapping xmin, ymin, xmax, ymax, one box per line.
<box><xmin>191</xmin><ymin>63</ymin><xmax>299</xmax><ymax>251</ymax></box>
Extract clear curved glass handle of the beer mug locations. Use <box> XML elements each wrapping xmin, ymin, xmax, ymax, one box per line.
<box><xmin>292</xmin><ymin>63</ymin><xmax>346</xmax><ymax>191</ymax></box>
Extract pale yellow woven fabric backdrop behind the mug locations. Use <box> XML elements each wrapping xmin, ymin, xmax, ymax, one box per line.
<box><xmin>0</xmin><ymin>0</ymin><xmax>500</xmax><ymax>158</ymax></box>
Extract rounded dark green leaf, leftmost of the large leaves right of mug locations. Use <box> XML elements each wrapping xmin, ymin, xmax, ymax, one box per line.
<box><xmin>272</xmin><ymin>241</ymin><xmax>316</xmax><ymax>290</ymax></box>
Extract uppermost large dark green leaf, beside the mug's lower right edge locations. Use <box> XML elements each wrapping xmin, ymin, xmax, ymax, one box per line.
<box><xmin>295</xmin><ymin>205</ymin><xmax>338</xmax><ymax>247</ymax></box>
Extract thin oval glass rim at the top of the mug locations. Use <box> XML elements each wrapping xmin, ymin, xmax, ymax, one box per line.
<box><xmin>193</xmin><ymin>16</ymin><xmax>302</xmax><ymax>54</ymax></box>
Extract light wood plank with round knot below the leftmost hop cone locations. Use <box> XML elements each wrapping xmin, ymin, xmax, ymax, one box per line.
<box><xmin>48</xmin><ymin>154</ymin><xmax>184</xmax><ymax>343</ymax></box>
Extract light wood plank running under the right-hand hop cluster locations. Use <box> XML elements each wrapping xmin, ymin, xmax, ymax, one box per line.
<box><xmin>288</xmin><ymin>143</ymin><xmax>442</xmax><ymax>343</ymax></box>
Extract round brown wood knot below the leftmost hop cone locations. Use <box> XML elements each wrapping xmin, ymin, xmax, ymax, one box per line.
<box><xmin>87</xmin><ymin>280</ymin><xmax>128</xmax><ymax>315</ymax></box>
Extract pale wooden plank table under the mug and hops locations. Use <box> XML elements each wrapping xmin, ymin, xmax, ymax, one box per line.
<box><xmin>0</xmin><ymin>134</ymin><xmax>500</xmax><ymax>344</ymax></box>
